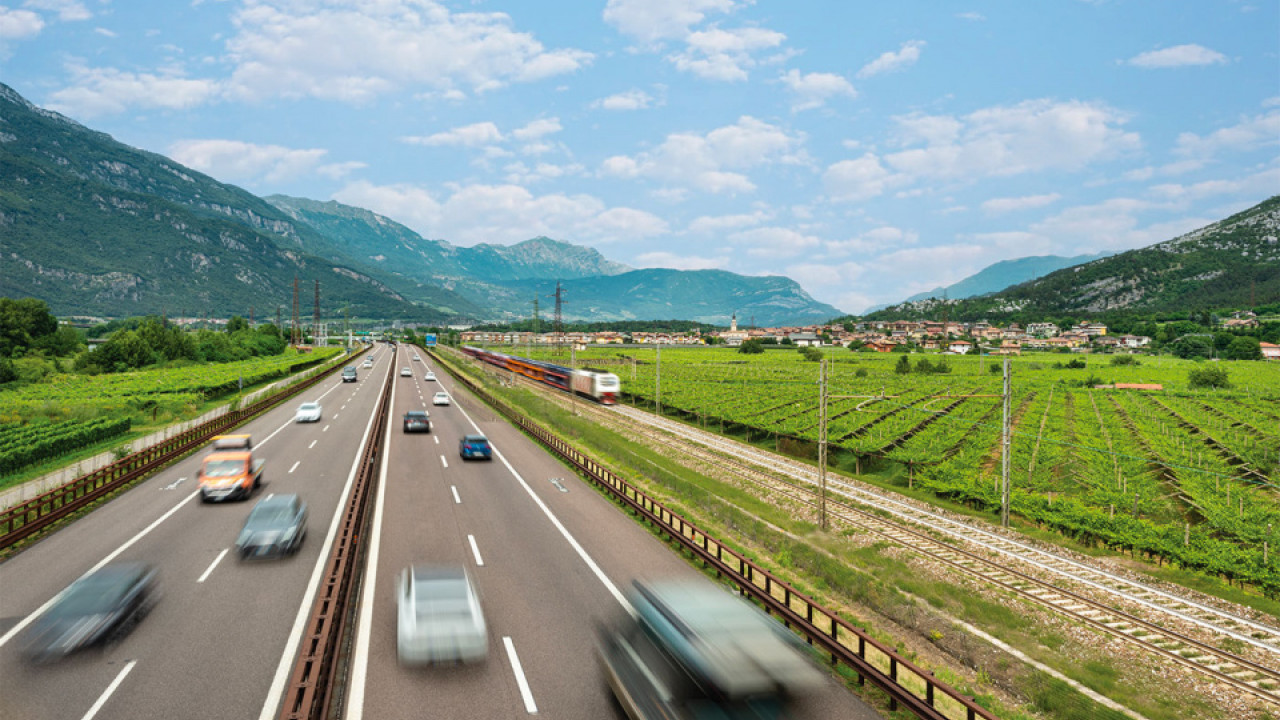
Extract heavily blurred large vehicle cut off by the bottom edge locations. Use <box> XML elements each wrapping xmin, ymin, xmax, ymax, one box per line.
<box><xmin>598</xmin><ymin>580</ymin><xmax>822</xmax><ymax>720</ymax></box>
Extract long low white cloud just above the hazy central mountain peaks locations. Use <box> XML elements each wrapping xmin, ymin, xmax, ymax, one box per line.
<box><xmin>334</xmin><ymin>181</ymin><xmax>668</xmax><ymax>245</ymax></box>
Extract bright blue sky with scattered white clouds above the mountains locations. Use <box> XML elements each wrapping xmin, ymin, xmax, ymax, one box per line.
<box><xmin>0</xmin><ymin>0</ymin><xmax>1280</xmax><ymax>313</ymax></box>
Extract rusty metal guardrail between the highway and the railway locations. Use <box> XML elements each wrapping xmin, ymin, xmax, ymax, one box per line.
<box><xmin>436</xmin><ymin>345</ymin><xmax>996</xmax><ymax>720</ymax></box>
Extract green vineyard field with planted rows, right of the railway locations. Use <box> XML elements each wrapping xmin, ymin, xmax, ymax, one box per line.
<box><xmin>516</xmin><ymin>347</ymin><xmax>1280</xmax><ymax>596</ymax></box>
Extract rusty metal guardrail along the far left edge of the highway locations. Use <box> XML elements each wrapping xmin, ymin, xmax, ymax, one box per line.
<box><xmin>0</xmin><ymin>351</ymin><xmax>360</xmax><ymax>550</ymax></box>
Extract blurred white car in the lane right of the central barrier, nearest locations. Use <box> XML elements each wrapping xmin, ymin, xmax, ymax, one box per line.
<box><xmin>396</xmin><ymin>565</ymin><xmax>489</xmax><ymax>664</ymax></box>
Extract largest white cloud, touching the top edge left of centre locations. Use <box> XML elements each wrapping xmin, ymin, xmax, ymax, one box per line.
<box><xmin>227</xmin><ymin>0</ymin><xmax>593</xmax><ymax>102</ymax></box>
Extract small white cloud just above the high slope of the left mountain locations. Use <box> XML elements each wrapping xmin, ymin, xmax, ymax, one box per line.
<box><xmin>49</xmin><ymin>65</ymin><xmax>220</xmax><ymax>118</ymax></box>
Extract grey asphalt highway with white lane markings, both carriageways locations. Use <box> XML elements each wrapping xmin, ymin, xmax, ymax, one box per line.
<box><xmin>0</xmin><ymin>347</ymin><xmax>878</xmax><ymax>720</ymax></box>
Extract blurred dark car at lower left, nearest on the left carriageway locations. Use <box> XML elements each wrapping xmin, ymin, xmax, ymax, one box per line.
<box><xmin>26</xmin><ymin>562</ymin><xmax>156</xmax><ymax>662</ymax></box>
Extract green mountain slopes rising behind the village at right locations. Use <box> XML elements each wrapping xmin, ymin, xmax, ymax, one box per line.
<box><xmin>873</xmin><ymin>196</ymin><xmax>1280</xmax><ymax>320</ymax></box>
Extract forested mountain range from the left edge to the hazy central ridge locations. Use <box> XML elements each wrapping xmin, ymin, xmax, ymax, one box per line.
<box><xmin>0</xmin><ymin>79</ymin><xmax>841</xmax><ymax>324</ymax></box>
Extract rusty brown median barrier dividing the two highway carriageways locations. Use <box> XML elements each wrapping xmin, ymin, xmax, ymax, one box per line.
<box><xmin>279</xmin><ymin>345</ymin><xmax>396</xmax><ymax>720</ymax></box>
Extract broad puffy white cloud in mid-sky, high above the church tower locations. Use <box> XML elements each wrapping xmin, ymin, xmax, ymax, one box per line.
<box><xmin>602</xmin><ymin>115</ymin><xmax>805</xmax><ymax>192</ymax></box>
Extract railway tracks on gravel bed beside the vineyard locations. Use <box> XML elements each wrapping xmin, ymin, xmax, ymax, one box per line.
<box><xmin>596</xmin><ymin>406</ymin><xmax>1280</xmax><ymax>705</ymax></box>
